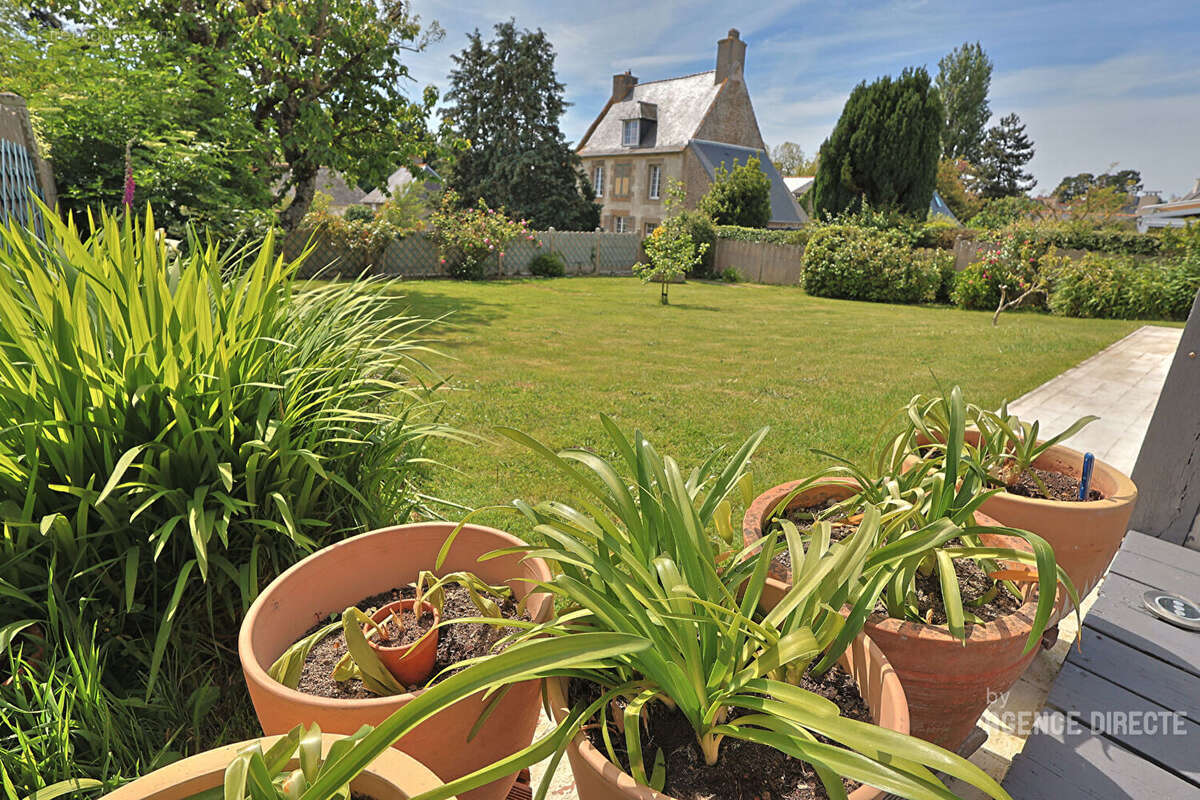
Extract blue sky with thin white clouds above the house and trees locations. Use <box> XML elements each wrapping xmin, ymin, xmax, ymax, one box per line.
<box><xmin>410</xmin><ymin>0</ymin><xmax>1200</xmax><ymax>196</ymax></box>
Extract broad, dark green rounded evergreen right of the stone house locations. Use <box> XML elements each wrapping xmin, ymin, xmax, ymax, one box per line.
<box><xmin>812</xmin><ymin>67</ymin><xmax>942</xmax><ymax>218</ymax></box>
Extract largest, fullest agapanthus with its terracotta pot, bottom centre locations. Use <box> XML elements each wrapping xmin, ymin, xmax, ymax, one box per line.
<box><xmin>492</xmin><ymin>420</ymin><xmax>1008</xmax><ymax>800</ymax></box>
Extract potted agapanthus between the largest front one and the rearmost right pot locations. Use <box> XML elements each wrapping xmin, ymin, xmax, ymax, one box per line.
<box><xmin>743</xmin><ymin>389</ymin><xmax>1076</xmax><ymax>748</ymax></box>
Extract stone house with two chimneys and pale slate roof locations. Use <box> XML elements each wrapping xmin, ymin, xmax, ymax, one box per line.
<box><xmin>576</xmin><ymin>30</ymin><xmax>808</xmax><ymax>235</ymax></box>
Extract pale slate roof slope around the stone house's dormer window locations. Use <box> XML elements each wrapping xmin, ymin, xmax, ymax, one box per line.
<box><xmin>578</xmin><ymin>70</ymin><xmax>721</xmax><ymax>156</ymax></box>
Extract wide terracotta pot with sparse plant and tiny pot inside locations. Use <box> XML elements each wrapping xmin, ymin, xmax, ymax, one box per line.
<box><xmin>238</xmin><ymin>522</ymin><xmax>553</xmax><ymax>800</ymax></box>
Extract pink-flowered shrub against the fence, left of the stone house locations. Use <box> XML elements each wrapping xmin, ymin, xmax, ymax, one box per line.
<box><xmin>432</xmin><ymin>191</ymin><xmax>530</xmax><ymax>281</ymax></box>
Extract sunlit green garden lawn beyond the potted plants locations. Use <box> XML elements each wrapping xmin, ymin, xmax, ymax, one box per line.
<box><xmin>362</xmin><ymin>278</ymin><xmax>1141</xmax><ymax>530</ymax></box>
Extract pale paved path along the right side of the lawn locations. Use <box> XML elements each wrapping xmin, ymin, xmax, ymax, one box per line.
<box><xmin>1008</xmin><ymin>325</ymin><xmax>1183</xmax><ymax>475</ymax></box>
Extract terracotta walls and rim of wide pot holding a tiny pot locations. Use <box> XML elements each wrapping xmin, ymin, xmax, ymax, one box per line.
<box><xmin>238</xmin><ymin>522</ymin><xmax>553</xmax><ymax>800</ymax></box>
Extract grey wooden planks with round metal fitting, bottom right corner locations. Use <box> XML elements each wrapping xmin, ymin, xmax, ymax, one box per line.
<box><xmin>1004</xmin><ymin>531</ymin><xmax>1200</xmax><ymax>800</ymax></box>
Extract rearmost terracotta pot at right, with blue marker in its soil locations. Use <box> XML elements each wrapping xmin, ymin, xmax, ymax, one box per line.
<box><xmin>906</xmin><ymin>431</ymin><xmax>1138</xmax><ymax>597</ymax></box>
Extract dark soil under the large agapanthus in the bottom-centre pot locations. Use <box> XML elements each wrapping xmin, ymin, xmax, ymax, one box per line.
<box><xmin>569</xmin><ymin>666</ymin><xmax>871</xmax><ymax>800</ymax></box>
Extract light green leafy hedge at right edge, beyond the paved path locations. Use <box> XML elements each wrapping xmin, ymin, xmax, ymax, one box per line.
<box><xmin>1050</xmin><ymin>253</ymin><xmax>1200</xmax><ymax>319</ymax></box>
